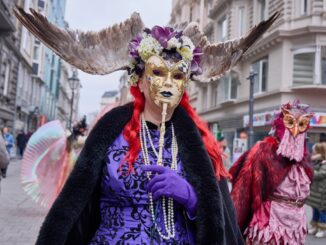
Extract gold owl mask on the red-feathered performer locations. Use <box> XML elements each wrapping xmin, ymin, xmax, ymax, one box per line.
<box><xmin>282</xmin><ymin>109</ymin><xmax>312</xmax><ymax>137</ymax></box>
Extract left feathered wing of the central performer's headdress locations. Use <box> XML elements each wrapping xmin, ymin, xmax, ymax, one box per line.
<box><xmin>14</xmin><ymin>6</ymin><xmax>144</xmax><ymax>75</ymax></box>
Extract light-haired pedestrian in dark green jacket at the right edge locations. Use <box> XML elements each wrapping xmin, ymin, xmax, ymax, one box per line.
<box><xmin>306</xmin><ymin>142</ymin><xmax>326</xmax><ymax>238</ymax></box>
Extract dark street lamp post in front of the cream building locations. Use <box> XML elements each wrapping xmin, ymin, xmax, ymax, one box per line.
<box><xmin>247</xmin><ymin>69</ymin><xmax>258</xmax><ymax>149</ymax></box>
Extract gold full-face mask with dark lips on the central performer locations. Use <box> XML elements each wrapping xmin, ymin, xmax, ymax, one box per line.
<box><xmin>144</xmin><ymin>56</ymin><xmax>189</xmax><ymax>107</ymax></box>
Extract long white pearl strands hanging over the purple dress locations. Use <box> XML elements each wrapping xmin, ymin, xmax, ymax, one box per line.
<box><xmin>140</xmin><ymin>114</ymin><xmax>178</xmax><ymax>240</ymax></box>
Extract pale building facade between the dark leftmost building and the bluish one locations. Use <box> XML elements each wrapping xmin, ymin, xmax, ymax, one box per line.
<box><xmin>15</xmin><ymin>0</ymin><xmax>44</xmax><ymax>132</ymax></box>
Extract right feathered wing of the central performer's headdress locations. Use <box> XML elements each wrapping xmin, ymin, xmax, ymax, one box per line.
<box><xmin>183</xmin><ymin>12</ymin><xmax>279</xmax><ymax>83</ymax></box>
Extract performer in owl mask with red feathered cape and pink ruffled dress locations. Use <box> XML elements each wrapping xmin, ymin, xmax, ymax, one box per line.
<box><xmin>230</xmin><ymin>102</ymin><xmax>313</xmax><ymax>244</ymax></box>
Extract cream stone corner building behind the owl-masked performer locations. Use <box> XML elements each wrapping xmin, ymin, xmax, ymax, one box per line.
<box><xmin>171</xmin><ymin>0</ymin><xmax>326</xmax><ymax>151</ymax></box>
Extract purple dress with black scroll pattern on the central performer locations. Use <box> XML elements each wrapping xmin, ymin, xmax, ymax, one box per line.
<box><xmin>90</xmin><ymin>123</ymin><xmax>193</xmax><ymax>244</ymax></box>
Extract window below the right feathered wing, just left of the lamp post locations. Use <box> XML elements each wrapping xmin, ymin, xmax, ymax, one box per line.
<box><xmin>217</xmin><ymin>72</ymin><xmax>239</xmax><ymax>103</ymax></box>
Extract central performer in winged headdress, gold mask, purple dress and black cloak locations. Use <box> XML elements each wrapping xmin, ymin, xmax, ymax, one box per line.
<box><xmin>15</xmin><ymin>6</ymin><xmax>276</xmax><ymax>244</ymax></box>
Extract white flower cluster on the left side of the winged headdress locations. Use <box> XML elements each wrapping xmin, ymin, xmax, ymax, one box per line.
<box><xmin>138</xmin><ymin>36</ymin><xmax>163</xmax><ymax>62</ymax></box>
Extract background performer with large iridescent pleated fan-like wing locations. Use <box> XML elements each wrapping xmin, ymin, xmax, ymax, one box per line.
<box><xmin>21</xmin><ymin>118</ymin><xmax>87</xmax><ymax>208</ymax></box>
